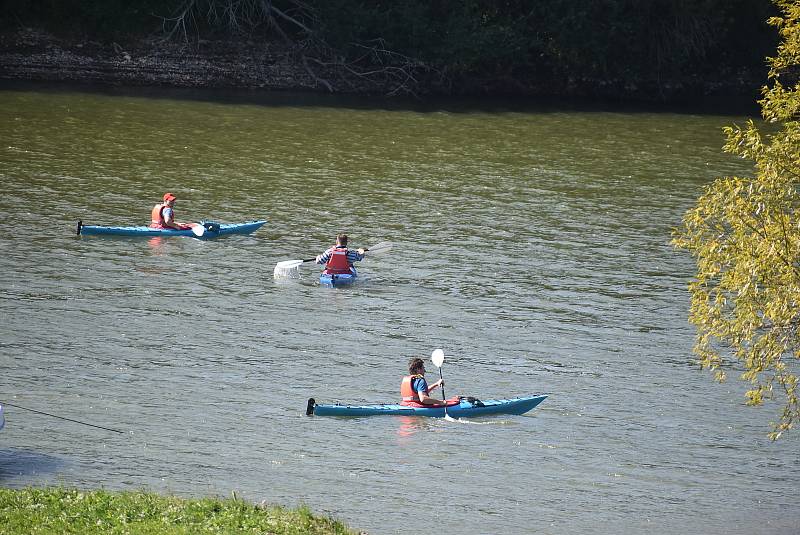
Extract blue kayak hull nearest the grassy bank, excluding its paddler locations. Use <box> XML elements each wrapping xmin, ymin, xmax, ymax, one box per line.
<box><xmin>306</xmin><ymin>395</ymin><xmax>547</xmax><ymax>418</ymax></box>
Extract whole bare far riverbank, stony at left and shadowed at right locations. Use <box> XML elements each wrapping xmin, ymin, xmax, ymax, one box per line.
<box><xmin>0</xmin><ymin>28</ymin><xmax>764</xmax><ymax>104</ymax></box>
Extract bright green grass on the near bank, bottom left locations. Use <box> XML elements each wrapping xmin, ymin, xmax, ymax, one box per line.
<box><xmin>0</xmin><ymin>488</ymin><xmax>355</xmax><ymax>535</ymax></box>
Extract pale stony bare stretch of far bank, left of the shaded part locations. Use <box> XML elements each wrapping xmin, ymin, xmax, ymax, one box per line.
<box><xmin>0</xmin><ymin>28</ymin><xmax>362</xmax><ymax>92</ymax></box>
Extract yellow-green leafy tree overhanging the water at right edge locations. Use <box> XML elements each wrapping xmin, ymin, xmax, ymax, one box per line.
<box><xmin>673</xmin><ymin>0</ymin><xmax>800</xmax><ymax>439</ymax></box>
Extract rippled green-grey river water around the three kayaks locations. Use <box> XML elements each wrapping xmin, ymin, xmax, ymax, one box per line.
<box><xmin>0</xmin><ymin>88</ymin><xmax>800</xmax><ymax>534</ymax></box>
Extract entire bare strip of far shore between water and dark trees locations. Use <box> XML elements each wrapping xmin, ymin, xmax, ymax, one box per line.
<box><xmin>0</xmin><ymin>28</ymin><xmax>763</xmax><ymax>112</ymax></box>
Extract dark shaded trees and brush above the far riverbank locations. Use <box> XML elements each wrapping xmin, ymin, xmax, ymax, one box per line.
<box><xmin>0</xmin><ymin>0</ymin><xmax>776</xmax><ymax>100</ymax></box>
